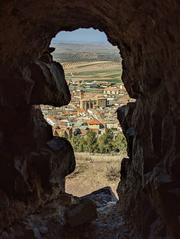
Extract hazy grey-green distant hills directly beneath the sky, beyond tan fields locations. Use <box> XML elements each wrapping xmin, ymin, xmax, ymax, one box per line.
<box><xmin>51</xmin><ymin>43</ymin><xmax>121</xmax><ymax>62</ymax></box>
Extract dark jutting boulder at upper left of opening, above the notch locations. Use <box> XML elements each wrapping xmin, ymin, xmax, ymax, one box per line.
<box><xmin>29</xmin><ymin>58</ymin><xmax>71</xmax><ymax>106</ymax></box>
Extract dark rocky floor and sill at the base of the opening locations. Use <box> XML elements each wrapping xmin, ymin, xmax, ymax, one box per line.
<box><xmin>0</xmin><ymin>188</ymin><xmax>126</xmax><ymax>239</ymax></box>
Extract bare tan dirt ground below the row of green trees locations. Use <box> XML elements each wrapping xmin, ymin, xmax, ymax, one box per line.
<box><xmin>66</xmin><ymin>153</ymin><xmax>124</xmax><ymax>196</ymax></box>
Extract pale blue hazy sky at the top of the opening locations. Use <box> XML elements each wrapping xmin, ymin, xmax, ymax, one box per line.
<box><xmin>52</xmin><ymin>28</ymin><xmax>107</xmax><ymax>43</ymax></box>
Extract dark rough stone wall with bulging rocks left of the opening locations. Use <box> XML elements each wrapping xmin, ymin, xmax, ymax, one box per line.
<box><xmin>0</xmin><ymin>46</ymin><xmax>75</xmax><ymax>230</ymax></box>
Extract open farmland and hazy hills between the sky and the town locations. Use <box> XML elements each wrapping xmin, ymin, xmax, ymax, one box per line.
<box><xmin>52</xmin><ymin>43</ymin><xmax>122</xmax><ymax>84</ymax></box>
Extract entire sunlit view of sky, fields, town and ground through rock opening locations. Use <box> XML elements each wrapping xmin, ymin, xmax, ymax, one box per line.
<box><xmin>41</xmin><ymin>29</ymin><xmax>130</xmax><ymax>196</ymax></box>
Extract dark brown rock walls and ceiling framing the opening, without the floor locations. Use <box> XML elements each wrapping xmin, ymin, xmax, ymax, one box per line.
<box><xmin>0</xmin><ymin>0</ymin><xmax>180</xmax><ymax>238</ymax></box>
